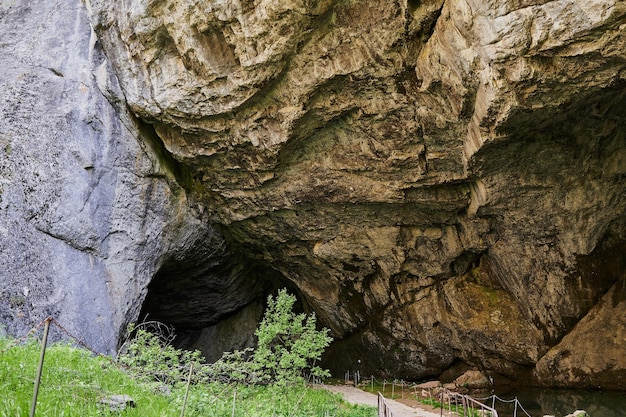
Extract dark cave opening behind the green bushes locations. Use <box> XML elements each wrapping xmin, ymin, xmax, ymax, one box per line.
<box><xmin>139</xmin><ymin>247</ymin><xmax>285</xmax><ymax>362</ymax></box>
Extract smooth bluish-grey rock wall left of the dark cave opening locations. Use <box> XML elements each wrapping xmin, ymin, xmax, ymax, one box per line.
<box><xmin>0</xmin><ymin>0</ymin><xmax>258</xmax><ymax>352</ymax></box>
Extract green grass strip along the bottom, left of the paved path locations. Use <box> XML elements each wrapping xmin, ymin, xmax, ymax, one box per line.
<box><xmin>0</xmin><ymin>337</ymin><xmax>376</xmax><ymax>417</ymax></box>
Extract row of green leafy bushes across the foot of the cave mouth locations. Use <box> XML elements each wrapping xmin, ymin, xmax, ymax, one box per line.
<box><xmin>118</xmin><ymin>289</ymin><xmax>332</xmax><ymax>386</ymax></box>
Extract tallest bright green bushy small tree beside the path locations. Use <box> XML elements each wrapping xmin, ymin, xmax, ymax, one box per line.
<box><xmin>253</xmin><ymin>289</ymin><xmax>332</xmax><ymax>385</ymax></box>
